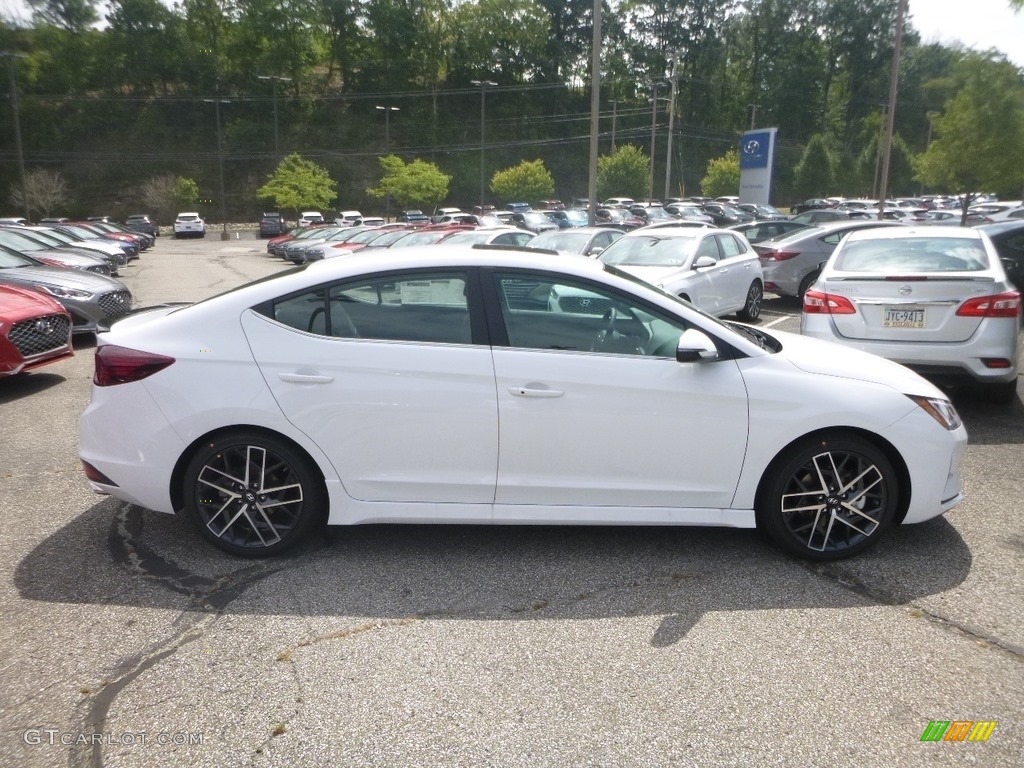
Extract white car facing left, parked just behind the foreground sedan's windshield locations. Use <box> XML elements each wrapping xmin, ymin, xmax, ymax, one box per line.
<box><xmin>598</xmin><ymin>225</ymin><xmax>765</xmax><ymax>322</ymax></box>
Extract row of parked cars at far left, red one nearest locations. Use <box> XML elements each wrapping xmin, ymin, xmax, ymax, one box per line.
<box><xmin>0</xmin><ymin>218</ymin><xmax>148</xmax><ymax>377</ymax></box>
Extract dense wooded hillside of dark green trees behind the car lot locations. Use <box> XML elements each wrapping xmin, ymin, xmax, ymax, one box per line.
<box><xmin>0</xmin><ymin>0</ymin><xmax>1024</xmax><ymax>218</ymax></box>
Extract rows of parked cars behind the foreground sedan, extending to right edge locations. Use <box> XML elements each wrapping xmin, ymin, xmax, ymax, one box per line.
<box><xmin>267</xmin><ymin>207</ymin><xmax>1024</xmax><ymax>400</ymax></box>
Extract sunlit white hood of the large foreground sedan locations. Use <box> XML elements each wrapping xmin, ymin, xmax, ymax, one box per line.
<box><xmin>765</xmin><ymin>329</ymin><xmax>948</xmax><ymax>399</ymax></box>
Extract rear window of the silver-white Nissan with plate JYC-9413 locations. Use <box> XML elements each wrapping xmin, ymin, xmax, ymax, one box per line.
<box><xmin>833</xmin><ymin>238</ymin><xmax>989</xmax><ymax>274</ymax></box>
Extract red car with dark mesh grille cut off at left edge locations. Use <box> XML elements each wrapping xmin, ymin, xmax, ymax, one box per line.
<box><xmin>0</xmin><ymin>284</ymin><xmax>75</xmax><ymax>377</ymax></box>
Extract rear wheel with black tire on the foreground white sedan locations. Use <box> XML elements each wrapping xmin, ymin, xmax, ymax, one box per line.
<box><xmin>182</xmin><ymin>432</ymin><xmax>327</xmax><ymax>557</ymax></box>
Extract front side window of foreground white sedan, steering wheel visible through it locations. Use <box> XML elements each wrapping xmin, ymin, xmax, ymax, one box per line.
<box><xmin>495</xmin><ymin>272</ymin><xmax>686</xmax><ymax>357</ymax></box>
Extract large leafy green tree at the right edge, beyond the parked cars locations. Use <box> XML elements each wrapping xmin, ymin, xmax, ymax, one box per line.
<box><xmin>914</xmin><ymin>52</ymin><xmax>1024</xmax><ymax>211</ymax></box>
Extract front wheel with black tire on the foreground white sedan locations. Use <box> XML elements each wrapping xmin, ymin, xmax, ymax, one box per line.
<box><xmin>757</xmin><ymin>433</ymin><xmax>899</xmax><ymax>560</ymax></box>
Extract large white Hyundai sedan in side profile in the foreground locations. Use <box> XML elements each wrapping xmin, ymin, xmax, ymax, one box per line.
<box><xmin>80</xmin><ymin>245</ymin><xmax>967</xmax><ymax>559</ymax></box>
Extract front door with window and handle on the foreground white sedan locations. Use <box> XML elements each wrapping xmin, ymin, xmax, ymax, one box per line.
<box><xmin>483</xmin><ymin>271</ymin><xmax>748</xmax><ymax>522</ymax></box>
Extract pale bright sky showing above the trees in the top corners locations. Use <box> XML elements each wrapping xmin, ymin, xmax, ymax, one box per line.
<box><xmin>0</xmin><ymin>0</ymin><xmax>1024</xmax><ymax>67</ymax></box>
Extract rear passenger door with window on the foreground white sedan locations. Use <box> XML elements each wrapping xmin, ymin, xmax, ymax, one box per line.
<box><xmin>243</xmin><ymin>270</ymin><xmax>498</xmax><ymax>512</ymax></box>
